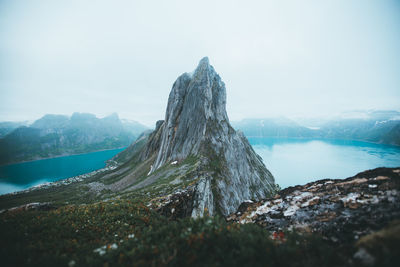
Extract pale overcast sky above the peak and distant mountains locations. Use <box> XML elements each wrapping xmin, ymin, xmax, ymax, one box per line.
<box><xmin>0</xmin><ymin>0</ymin><xmax>400</xmax><ymax>126</ymax></box>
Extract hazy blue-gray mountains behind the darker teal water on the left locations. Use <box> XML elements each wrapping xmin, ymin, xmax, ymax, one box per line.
<box><xmin>0</xmin><ymin>113</ymin><xmax>148</xmax><ymax>164</ymax></box>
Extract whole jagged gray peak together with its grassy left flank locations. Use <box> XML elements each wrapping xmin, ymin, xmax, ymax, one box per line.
<box><xmin>100</xmin><ymin>58</ymin><xmax>276</xmax><ymax>217</ymax></box>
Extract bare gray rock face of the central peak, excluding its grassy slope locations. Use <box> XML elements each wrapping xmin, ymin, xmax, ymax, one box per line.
<box><xmin>150</xmin><ymin>58</ymin><xmax>275</xmax><ymax>217</ymax></box>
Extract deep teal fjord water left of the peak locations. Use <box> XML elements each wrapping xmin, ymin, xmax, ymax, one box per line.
<box><xmin>0</xmin><ymin>148</ymin><xmax>123</xmax><ymax>194</ymax></box>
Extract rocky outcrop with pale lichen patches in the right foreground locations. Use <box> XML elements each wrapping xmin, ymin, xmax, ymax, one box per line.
<box><xmin>228</xmin><ymin>168</ymin><xmax>400</xmax><ymax>246</ymax></box>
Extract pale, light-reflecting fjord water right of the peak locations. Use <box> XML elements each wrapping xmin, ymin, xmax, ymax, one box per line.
<box><xmin>249</xmin><ymin>138</ymin><xmax>400</xmax><ymax>188</ymax></box>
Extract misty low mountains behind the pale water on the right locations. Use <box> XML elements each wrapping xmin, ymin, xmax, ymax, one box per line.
<box><xmin>232</xmin><ymin>110</ymin><xmax>400</xmax><ymax>145</ymax></box>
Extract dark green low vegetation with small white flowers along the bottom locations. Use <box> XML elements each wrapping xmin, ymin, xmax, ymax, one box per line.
<box><xmin>0</xmin><ymin>200</ymin><xmax>396</xmax><ymax>266</ymax></box>
